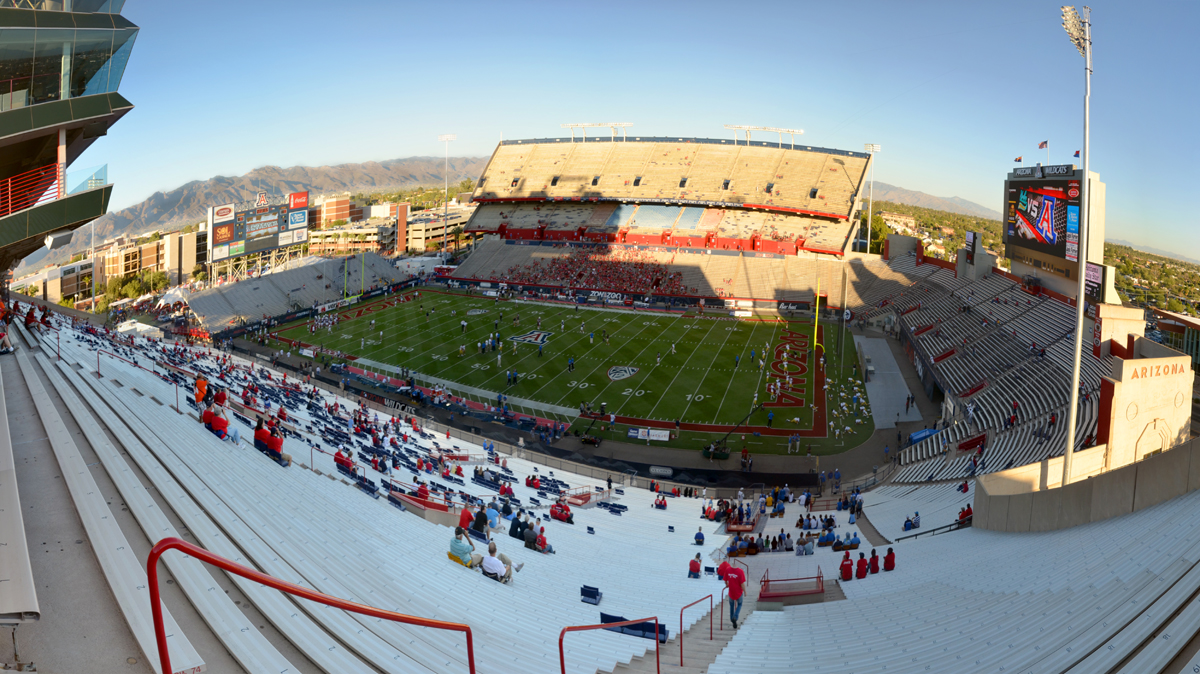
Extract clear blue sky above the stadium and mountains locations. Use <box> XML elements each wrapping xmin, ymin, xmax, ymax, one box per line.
<box><xmin>93</xmin><ymin>0</ymin><xmax>1200</xmax><ymax>258</ymax></box>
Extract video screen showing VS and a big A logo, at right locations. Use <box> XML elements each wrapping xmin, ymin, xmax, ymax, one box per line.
<box><xmin>1006</xmin><ymin>180</ymin><xmax>1080</xmax><ymax>261</ymax></box>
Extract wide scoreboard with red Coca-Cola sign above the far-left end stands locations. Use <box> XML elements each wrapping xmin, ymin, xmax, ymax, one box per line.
<box><xmin>208</xmin><ymin>192</ymin><xmax>308</xmax><ymax>263</ymax></box>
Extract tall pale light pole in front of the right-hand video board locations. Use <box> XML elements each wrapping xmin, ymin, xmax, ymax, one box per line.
<box><xmin>1062</xmin><ymin>5</ymin><xmax>1092</xmax><ymax>487</ymax></box>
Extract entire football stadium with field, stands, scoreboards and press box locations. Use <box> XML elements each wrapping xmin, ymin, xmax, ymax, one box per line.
<box><xmin>0</xmin><ymin>1</ymin><xmax>1200</xmax><ymax>674</ymax></box>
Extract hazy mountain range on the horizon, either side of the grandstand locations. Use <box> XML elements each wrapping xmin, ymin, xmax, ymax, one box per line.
<box><xmin>17</xmin><ymin>157</ymin><xmax>1001</xmax><ymax>271</ymax></box>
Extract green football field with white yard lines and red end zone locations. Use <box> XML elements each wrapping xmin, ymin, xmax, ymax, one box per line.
<box><xmin>275</xmin><ymin>291</ymin><xmax>874</xmax><ymax>453</ymax></box>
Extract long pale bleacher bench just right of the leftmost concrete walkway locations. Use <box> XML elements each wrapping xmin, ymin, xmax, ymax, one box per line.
<box><xmin>10</xmin><ymin>349</ymin><xmax>205</xmax><ymax>672</ymax></box>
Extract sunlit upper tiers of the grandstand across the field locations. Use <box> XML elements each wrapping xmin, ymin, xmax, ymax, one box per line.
<box><xmin>466</xmin><ymin>138</ymin><xmax>870</xmax><ymax>255</ymax></box>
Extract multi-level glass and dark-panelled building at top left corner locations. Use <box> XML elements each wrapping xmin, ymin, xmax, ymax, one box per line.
<box><xmin>0</xmin><ymin>0</ymin><xmax>138</xmax><ymax>274</ymax></box>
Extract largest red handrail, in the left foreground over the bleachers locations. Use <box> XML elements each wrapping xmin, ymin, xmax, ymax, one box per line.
<box><xmin>146</xmin><ymin>537</ymin><xmax>480</xmax><ymax>674</ymax></box>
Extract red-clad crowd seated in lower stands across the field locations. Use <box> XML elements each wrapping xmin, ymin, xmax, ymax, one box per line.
<box><xmin>492</xmin><ymin>247</ymin><xmax>698</xmax><ymax>295</ymax></box>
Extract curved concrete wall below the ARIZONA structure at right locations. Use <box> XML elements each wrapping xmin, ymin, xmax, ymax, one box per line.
<box><xmin>972</xmin><ymin>439</ymin><xmax>1200</xmax><ymax>532</ymax></box>
